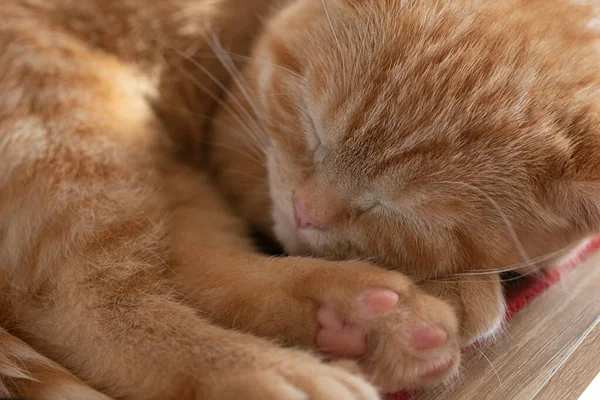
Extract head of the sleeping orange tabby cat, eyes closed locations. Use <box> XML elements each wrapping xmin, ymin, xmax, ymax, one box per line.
<box><xmin>253</xmin><ymin>0</ymin><xmax>600</xmax><ymax>276</ymax></box>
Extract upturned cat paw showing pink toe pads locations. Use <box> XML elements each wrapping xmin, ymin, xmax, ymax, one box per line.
<box><xmin>316</xmin><ymin>268</ymin><xmax>460</xmax><ymax>391</ymax></box>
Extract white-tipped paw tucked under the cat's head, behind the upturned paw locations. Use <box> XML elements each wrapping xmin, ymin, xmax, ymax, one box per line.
<box><xmin>419</xmin><ymin>273</ymin><xmax>506</xmax><ymax>346</ymax></box>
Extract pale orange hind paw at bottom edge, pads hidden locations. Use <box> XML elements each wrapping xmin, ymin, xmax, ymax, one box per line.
<box><xmin>211</xmin><ymin>351</ymin><xmax>380</xmax><ymax>400</ymax></box>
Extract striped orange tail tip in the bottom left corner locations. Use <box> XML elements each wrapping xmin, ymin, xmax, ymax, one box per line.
<box><xmin>0</xmin><ymin>327</ymin><xmax>111</xmax><ymax>400</ymax></box>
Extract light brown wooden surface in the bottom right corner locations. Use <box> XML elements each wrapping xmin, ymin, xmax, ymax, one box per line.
<box><xmin>414</xmin><ymin>254</ymin><xmax>600</xmax><ymax>400</ymax></box>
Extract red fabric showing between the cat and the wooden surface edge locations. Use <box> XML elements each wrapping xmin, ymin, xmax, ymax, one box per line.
<box><xmin>386</xmin><ymin>236</ymin><xmax>600</xmax><ymax>400</ymax></box>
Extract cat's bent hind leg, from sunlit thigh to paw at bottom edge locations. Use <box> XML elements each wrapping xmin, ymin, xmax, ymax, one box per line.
<box><xmin>0</xmin><ymin>43</ymin><xmax>377</xmax><ymax>400</ymax></box>
